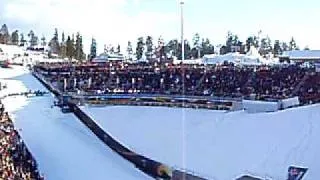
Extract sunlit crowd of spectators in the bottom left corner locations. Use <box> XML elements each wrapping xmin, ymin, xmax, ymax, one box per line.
<box><xmin>0</xmin><ymin>102</ymin><xmax>44</xmax><ymax>180</ymax></box>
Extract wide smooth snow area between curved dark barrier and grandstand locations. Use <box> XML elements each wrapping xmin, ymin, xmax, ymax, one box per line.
<box><xmin>83</xmin><ymin>105</ymin><xmax>320</xmax><ymax>180</ymax></box>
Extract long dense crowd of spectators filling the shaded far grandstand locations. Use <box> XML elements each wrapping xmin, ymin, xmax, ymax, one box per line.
<box><xmin>35</xmin><ymin>63</ymin><xmax>320</xmax><ymax>103</ymax></box>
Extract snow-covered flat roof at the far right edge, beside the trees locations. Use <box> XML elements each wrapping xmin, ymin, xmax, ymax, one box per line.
<box><xmin>280</xmin><ymin>50</ymin><xmax>320</xmax><ymax>60</ymax></box>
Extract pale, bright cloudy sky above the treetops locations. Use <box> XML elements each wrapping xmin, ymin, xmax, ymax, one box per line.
<box><xmin>0</xmin><ymin>0</ymin><xmax>320</xmax><ymax>51</ymax></box>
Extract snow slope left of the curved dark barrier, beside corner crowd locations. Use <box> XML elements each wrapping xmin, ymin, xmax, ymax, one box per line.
<box><xmin>0</xmin><ymin>67</ymin><xmax>151</xmax><ymax>180</ymax></box>
